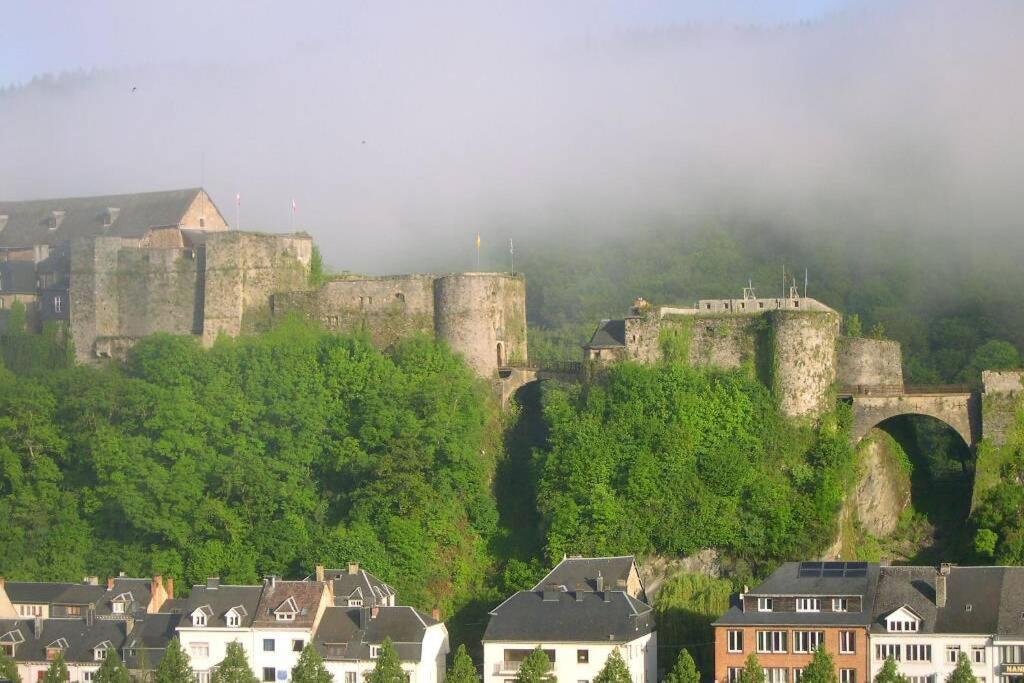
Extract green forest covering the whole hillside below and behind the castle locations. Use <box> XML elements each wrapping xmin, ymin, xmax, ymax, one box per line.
<box><xmin>0</xmin><ymin>220</ymin><xmax>1024</xmax><ymax>665</ymax></box>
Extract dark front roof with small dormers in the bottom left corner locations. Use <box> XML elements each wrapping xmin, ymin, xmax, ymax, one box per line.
<box><xmin>0</xmin><ymin>618</ymin><xmax>127</xmax><ymax>661</ymax></box>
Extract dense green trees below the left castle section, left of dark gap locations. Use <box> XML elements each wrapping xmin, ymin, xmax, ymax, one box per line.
<box><xmin>0</xmin><ymin>323</ymin><xmax>497</xmax><ymax>607</ymax></box>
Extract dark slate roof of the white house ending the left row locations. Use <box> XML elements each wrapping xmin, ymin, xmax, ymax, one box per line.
<box><xmin>313</xmin><ymin>606</ymin><xmax>438</xmax><ymax>661</ymax></box>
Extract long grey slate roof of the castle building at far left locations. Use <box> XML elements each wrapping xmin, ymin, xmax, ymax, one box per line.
<box><xmin>0</xmin><ymin>187</ymin><xmax>207</xmax><ymax>248</ymax></box>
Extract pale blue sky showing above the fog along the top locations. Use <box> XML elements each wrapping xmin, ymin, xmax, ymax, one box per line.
<box><xmin>0</xmin><ymin>0</ymin><xmax>850</xmax><ymax>86</ymax></box>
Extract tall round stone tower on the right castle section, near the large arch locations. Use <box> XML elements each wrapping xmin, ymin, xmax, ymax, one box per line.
<box><xmin>771</xmin><ymin>310</ymin><xmax>841</xmax><ymax>418</ymax></box>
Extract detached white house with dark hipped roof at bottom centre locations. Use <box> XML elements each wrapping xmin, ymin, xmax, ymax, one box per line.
<box><xmin>483</xmin><ymin>558</ymin><xmax>657</xmax><ymax>683</ymax></box>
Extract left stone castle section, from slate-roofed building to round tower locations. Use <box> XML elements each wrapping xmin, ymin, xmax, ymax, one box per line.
<box><xmin>0</xmin><ymin>187</ymin><xmax>526</xmax><ymax>378</ymax></box>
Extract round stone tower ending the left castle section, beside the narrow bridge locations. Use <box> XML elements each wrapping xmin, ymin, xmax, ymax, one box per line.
<box><xmin>434</xmin><ymin>272</ymin><xmax>527</xmax><ymax>378</ymax></box>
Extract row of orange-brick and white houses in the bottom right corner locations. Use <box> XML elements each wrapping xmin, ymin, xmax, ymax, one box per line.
<box><xmin>714</xmin><ymin>562</ymin><xmax>1024</xmax><ymax>683</ymax></box>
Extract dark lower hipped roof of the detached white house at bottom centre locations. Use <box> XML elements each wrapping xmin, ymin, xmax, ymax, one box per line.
<box><xmin>483</xmin><ymin>591</ymin><xmax>654</xmax><ymax>643</ymax></box>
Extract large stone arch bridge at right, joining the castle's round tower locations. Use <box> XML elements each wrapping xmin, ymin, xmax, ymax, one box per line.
<box><xmin>840</xmin><ymin>385</ymin><xmax>982</xmax><ymax>452</ymax></box>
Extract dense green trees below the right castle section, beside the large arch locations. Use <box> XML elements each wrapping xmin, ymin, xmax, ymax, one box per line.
<box><xmin>538</xmin><ymin>364</ymin><xmax>853</xmax><ymax>560</ymax></box>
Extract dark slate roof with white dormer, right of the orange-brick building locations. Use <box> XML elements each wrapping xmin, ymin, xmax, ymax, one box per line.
<box><xmin>871</xmin><ymin>566</ymin><xmax>1024</xmax><ymax>636</ymax></box>
